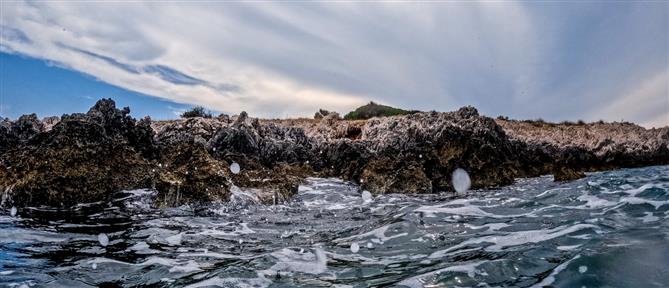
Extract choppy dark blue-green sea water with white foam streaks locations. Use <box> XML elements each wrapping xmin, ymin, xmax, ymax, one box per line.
<box><xmin>0</xmin><ymin>166</ymin><xmax>669</xmax><ymax>287</ymax></box>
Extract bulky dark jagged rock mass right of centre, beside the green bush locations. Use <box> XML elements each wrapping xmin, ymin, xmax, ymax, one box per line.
<box><xmin>316</xmin><ymin>107</ymin><xmax>515</xmax><ymax>193</ymax></box>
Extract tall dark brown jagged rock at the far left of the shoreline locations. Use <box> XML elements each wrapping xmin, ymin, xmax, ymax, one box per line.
<box><xmin>0</xmin><ymin>100</ymin><xmax>153</xmax><ymax>207</ymax></box>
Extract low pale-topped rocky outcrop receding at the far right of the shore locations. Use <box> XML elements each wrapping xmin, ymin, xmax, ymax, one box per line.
<box><xmin>496</xmin><ymin>119</ymin><xmax>669</xmax><ymax>181</ymax></box>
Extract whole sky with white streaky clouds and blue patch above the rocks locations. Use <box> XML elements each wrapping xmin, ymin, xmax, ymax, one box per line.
<box><xmin>0</xmin><ymin>1</ymin><xmax>669</xmax><ymax>127</ymax></box>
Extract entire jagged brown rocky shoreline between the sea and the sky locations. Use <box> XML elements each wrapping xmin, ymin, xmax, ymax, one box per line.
<box><xmin>0</xmin><ymin>99</ymin><xmax>669</xmax><ymax>208</ymax></box>
